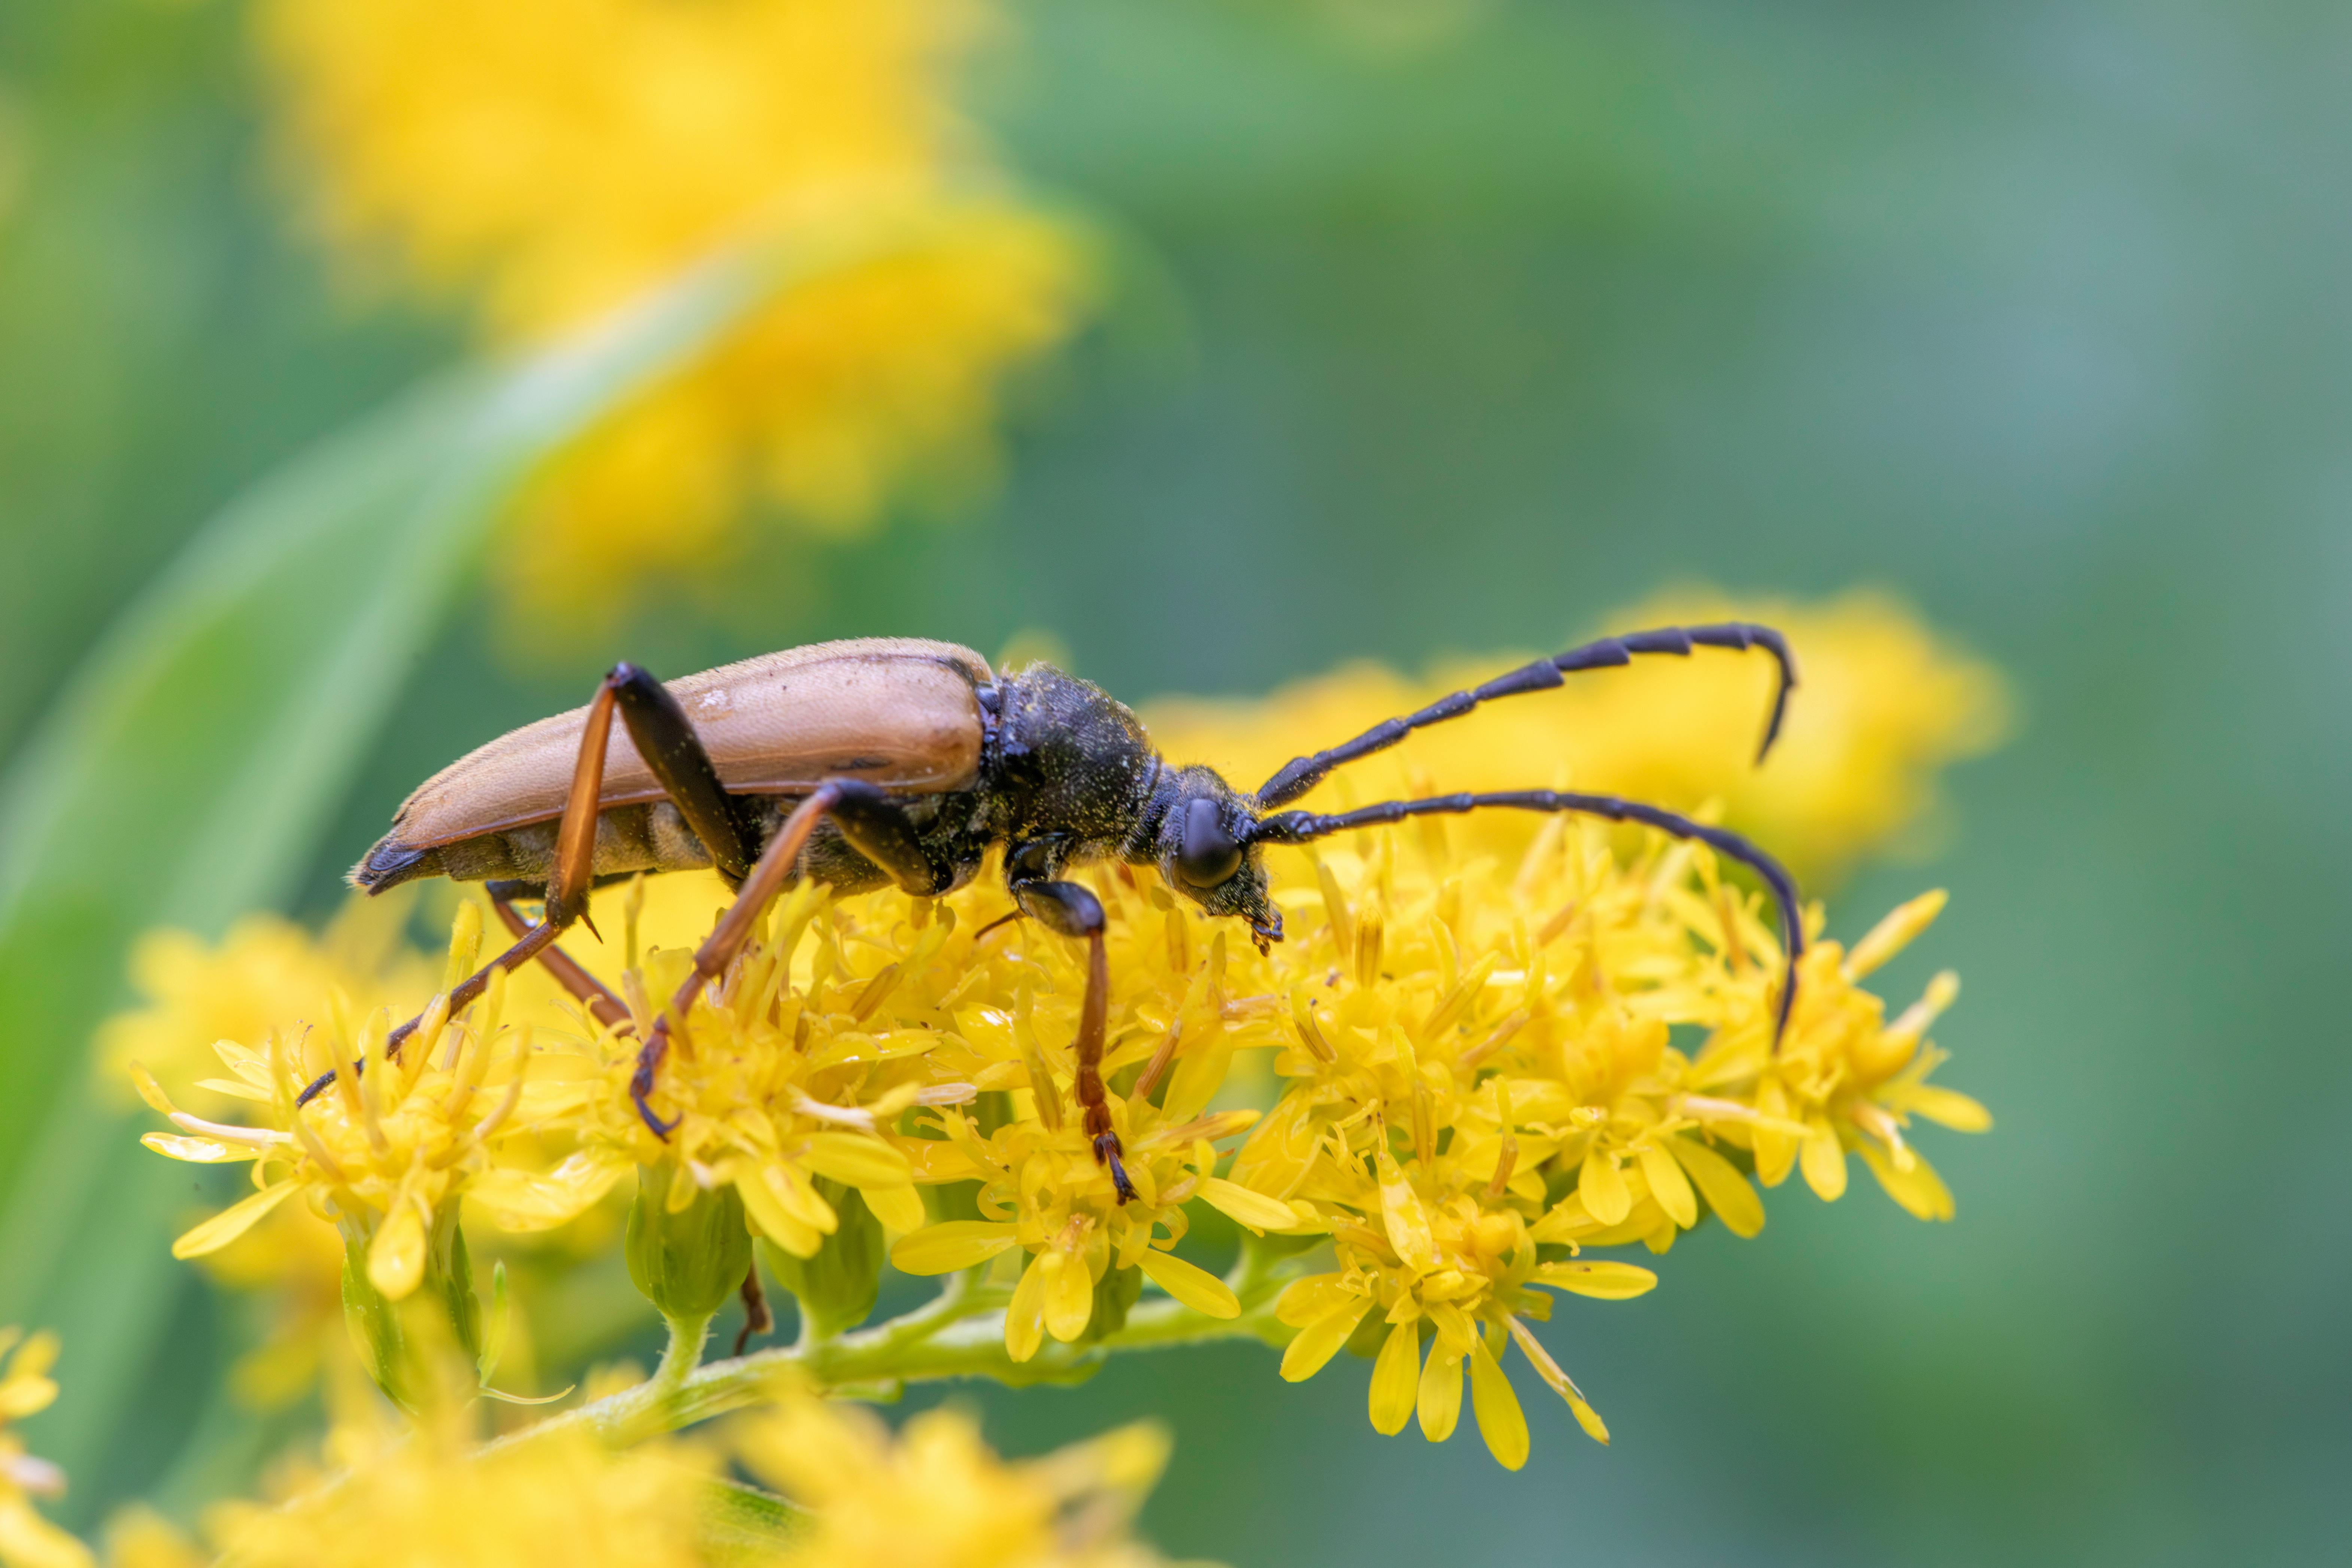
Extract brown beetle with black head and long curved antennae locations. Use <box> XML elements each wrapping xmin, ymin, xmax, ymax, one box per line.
<box><xmin>322</xmin><ymin>621</ymin><xmax>1804</xmax><ymax>1204</ymax></box>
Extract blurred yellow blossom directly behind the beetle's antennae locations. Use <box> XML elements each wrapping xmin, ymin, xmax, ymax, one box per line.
<box><xmin>1145</xmin><ymin>592</ymin><xmax>2009</xmax><ymax>882</ymax></box>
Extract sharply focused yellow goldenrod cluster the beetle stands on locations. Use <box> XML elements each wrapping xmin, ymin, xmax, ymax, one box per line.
<box><xmin>110</xmin><ymin>587</ymin><xmax>1990</xmax><ymax>1532</ymax></box>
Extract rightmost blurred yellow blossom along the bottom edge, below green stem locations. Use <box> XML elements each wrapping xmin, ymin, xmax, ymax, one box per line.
<box><xmin>736</xmin><ymin>1397</ymin><xmax>1169</xmax><ymax>1568</ymax></box>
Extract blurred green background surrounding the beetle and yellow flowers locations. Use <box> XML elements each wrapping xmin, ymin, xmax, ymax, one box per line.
<box><xmin>0</xmin><ymin>0</ymin><xmax>2352</xmax><ymax>1566</ymax></box>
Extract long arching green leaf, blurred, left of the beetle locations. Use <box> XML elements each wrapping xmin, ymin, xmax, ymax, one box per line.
<box><xmin>0</xmin><ymin>209</ymin><xmax>1011</xmax><ymax>1504</ymax></box>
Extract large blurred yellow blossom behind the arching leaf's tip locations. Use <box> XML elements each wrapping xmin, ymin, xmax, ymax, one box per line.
<box><xmin>259</xmin><ymin>0</ymin><xmax>1091</xmax><ymax>625</ymax></box>
